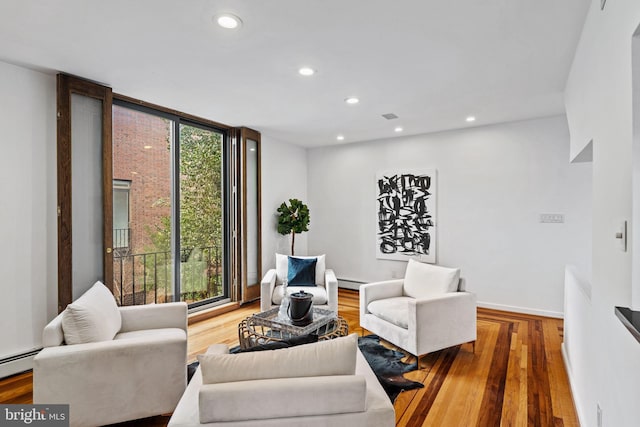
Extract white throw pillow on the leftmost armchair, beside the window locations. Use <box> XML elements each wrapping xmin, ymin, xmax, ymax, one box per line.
<box><xmin>62</xmin><ymin>282</ymin><xmax>122</xmax><ymax>344</ymax></box>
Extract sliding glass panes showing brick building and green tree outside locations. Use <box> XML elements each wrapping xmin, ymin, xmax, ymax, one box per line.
<box><xmin>113</xmin><ymin>101</ymin><xmax>230</xmax><ymax>306</ymax></box>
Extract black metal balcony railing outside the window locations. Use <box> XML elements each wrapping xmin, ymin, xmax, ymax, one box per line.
<box><xmin>113</xmin><ymin>246</ymin><xmax>224</xmax><ymax>306</ymax></box>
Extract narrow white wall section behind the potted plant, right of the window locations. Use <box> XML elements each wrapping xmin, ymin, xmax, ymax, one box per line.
<box><xmin>260</xmin><ymin>133</ymin><xmax>308</xmax><ymax>274</ymax></box>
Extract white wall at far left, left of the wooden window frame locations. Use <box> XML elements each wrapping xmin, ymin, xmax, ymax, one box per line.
<box><xmin>0</xmin><ymin>62</ymin><xmax>57</xmax><ymax>359</ymax></box>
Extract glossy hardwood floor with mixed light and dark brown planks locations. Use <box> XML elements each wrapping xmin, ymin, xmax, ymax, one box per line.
<box><xmin>0</xmin><ymin>289</ymin><xmax>579</xmax><ymax>427</ymax></box>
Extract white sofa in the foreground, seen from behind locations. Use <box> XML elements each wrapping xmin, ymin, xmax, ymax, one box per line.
<box><xmin>169</xmin><ymin>334</ymin><xmax>395</xmax><ymax>427</ymax></box>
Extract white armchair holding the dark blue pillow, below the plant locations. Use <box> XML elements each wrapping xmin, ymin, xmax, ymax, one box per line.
<box><xmin>260</xmin><ymin>254</ymin><xmax>338</xmax><ymax>313</ymax></box>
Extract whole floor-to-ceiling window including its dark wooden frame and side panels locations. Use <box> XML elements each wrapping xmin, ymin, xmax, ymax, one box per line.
<box><xmin>57</xmin><ymin>74</ymin><xmax>261</xmax><ymax>311</ymax></box>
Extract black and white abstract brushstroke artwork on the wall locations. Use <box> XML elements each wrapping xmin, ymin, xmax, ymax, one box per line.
<box><xmin>376</xmin><ymin>169</ymin><xmax>436</xmax><ymax>263</ymax></box>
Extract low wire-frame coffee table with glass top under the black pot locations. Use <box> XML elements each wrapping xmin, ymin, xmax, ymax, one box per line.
<box><xmin>238</xmin><ymin>307</ymin><xmax>349</xmax><ymax>349</ymax></box>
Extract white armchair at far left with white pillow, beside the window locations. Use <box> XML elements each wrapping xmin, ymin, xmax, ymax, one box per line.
<box><xmin>33</xmin><ymin>282</ymin><xmax>187</xmax><ymax>427</ymax></box>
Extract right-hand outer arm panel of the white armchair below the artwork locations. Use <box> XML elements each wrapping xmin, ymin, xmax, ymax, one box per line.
<box><xmin>408</xmin><ymin>292</ymin><xmax>477</xmax><ymax>348</ymax></box>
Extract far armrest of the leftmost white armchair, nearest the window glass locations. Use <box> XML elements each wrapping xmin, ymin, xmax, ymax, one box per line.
<box><xmin>119</xmin><ymin>302</ymin><xmax>187</xmax><ymax>332</ymax></box>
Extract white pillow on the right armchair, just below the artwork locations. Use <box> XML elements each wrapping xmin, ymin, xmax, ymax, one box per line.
<box><xmin>403</xmin><ymin>259</ymin><xmax>460</xmax><ymax>298</ymax></box>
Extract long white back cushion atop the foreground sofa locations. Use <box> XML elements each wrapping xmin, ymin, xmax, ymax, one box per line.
<box><xmin>198</xmin><ymin>334</ymin><xmax>358</xmax><ymax>384</ymax></box>
